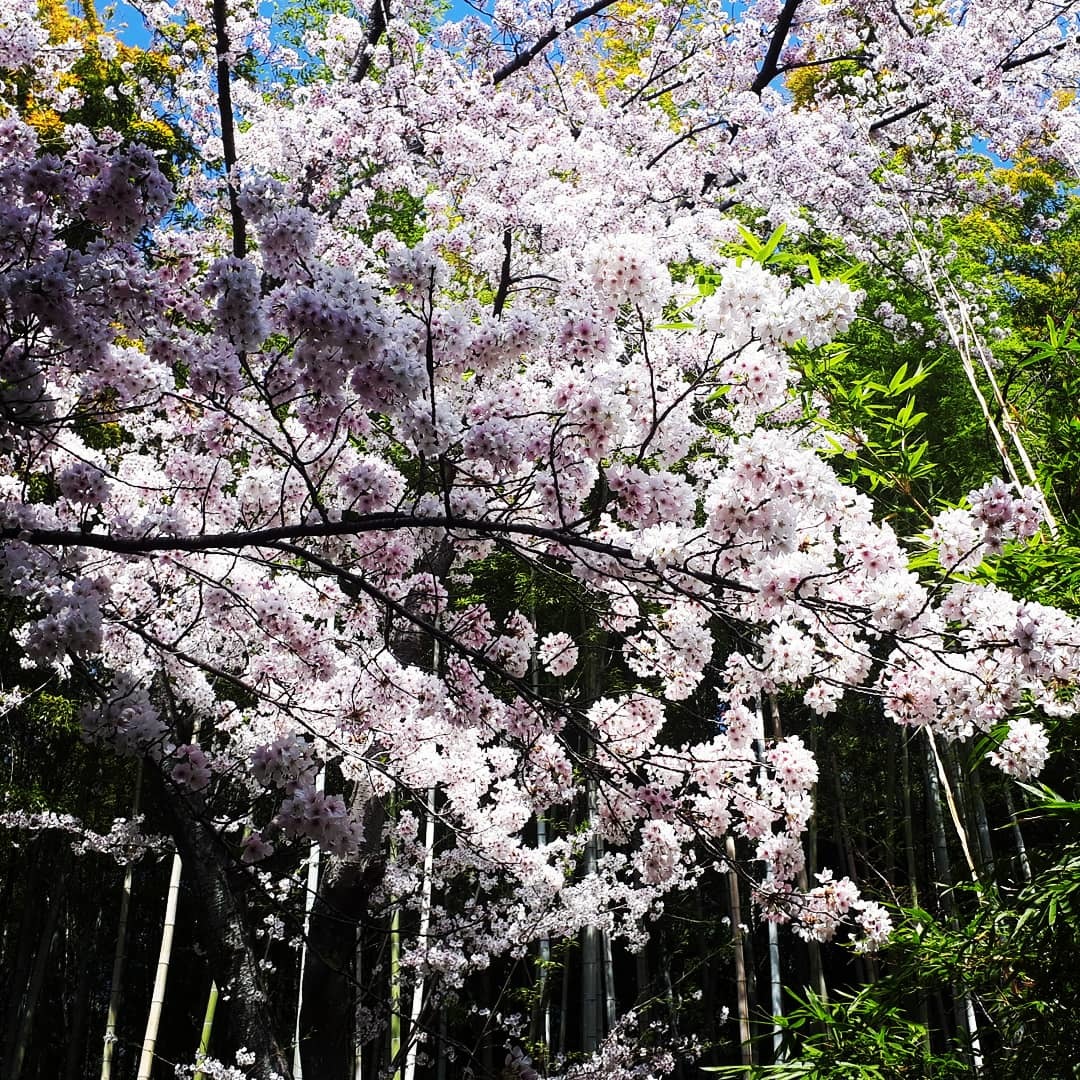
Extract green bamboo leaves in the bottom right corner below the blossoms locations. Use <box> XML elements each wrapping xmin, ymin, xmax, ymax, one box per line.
<box><xmin>747</xmin><ymin>812</ymin><xmax>1080</xmax><ymax>1080</ymax></box>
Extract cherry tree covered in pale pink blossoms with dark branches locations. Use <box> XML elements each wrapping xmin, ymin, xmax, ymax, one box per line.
<box><xmin>6</xmin><ymin>0</ymin><xmax>1080</xmax><ymax>1077</ymax></box>
